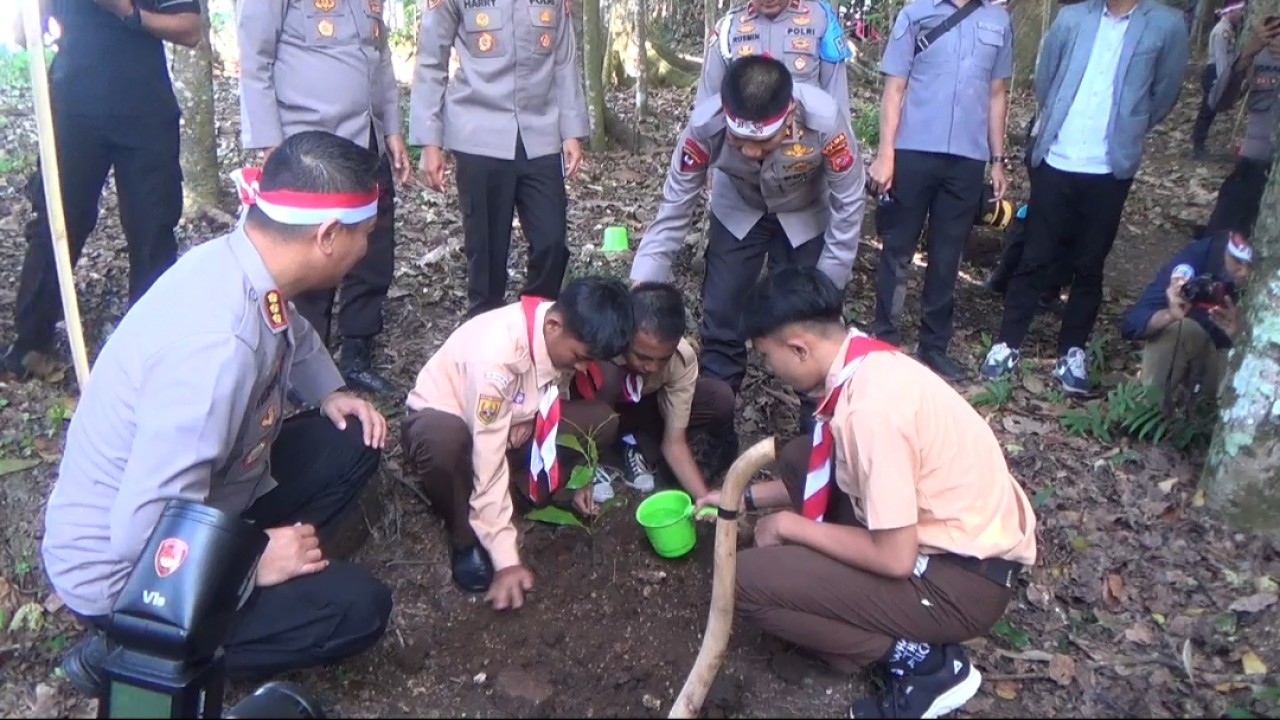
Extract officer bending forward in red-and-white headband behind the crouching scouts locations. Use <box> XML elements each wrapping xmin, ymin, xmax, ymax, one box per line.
<box><xmin>631</xmin><ymin>55</ymin><xmax>865</xmax><ymax>443</ymax></box>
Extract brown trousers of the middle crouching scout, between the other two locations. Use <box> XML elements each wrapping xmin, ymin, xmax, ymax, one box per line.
<box><xmin>573</xmin><ymin>363</ymin><xmax>737</xmax><ymax>466</ymax></box>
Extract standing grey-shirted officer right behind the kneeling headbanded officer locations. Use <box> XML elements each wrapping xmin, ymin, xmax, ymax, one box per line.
<box><xmin>236</xmin><ymin>0</ymin><xmax>412</xmax><ymax>395</ymax></box>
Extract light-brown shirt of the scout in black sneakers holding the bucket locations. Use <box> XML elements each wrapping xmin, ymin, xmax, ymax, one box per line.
<box><xmin>827</xmin><ymin>341</ymin><xmax>1036</xmax><ymax>565</ymax></box>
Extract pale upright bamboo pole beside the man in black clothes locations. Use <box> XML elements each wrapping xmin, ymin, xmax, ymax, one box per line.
<box><xmin>23</xmin><ymin>0</ymin><xmax>88</xmax><ymax>395</ymax></box>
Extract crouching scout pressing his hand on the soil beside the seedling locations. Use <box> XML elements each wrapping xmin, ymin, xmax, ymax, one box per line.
<box><xmin>401</xmin><ymin>278</ymin><xmax>635</xmax><ymax>610</ymax></box>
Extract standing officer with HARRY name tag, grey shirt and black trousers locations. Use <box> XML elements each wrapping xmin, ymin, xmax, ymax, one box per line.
<box><xmin>410</xmin><ymin>0</ymin><xmax>590</xmax><ymax>316</ymax></box>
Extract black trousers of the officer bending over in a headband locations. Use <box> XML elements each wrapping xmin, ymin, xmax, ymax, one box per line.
<box><xmin>698</xmin><ymin>208</ymin><xmax>826</xmax><ymax>395</ymax></box>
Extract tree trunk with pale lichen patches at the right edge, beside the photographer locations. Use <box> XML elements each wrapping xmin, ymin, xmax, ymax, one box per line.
<box><xmin>1201</xmin><ymin>135</ymin><xmax>1280</xmax><ymax>532</ymax></box>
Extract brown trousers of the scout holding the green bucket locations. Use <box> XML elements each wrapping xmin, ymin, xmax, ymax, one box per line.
<box><xmin>737</xmin><ymin>437</ymin><xmax>1014</xmax><ymax>674</ymax></box>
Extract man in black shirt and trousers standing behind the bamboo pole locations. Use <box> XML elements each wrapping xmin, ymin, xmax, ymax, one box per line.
<box><xmin>0</xmin><ymin>0</ymin><xmax>202</xmax><ymax>378</ymax></box>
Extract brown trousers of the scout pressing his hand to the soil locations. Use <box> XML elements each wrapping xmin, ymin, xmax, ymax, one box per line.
<box><xmin>401</xmin><ymin>400</ymin><xmax>618</xmax><ymax>548</ymax></box>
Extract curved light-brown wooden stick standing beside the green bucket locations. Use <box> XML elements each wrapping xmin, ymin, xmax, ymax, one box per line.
<box><xmin>667</xmin><ymin>437</ymin><xmax>776</xmax><ymax>717</ymax></box>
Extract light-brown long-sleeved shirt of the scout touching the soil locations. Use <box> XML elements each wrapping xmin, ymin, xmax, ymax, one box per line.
<box><xmin>407</xmin><ymin>297</ymin><xmax>567</xmax><ymax>570</ymax></box>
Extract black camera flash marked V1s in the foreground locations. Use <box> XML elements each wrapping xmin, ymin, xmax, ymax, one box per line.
<box><xmin>99</xmin><ymin>500</ymin><xmax>324</xmax><ymax>717</ymax></box>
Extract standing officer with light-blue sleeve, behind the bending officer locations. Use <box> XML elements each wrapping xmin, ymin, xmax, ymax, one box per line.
<box><xmin>695</xmin><ymin>0</ymin><xmax>850</xmax><ymax>118</ymax></box>
